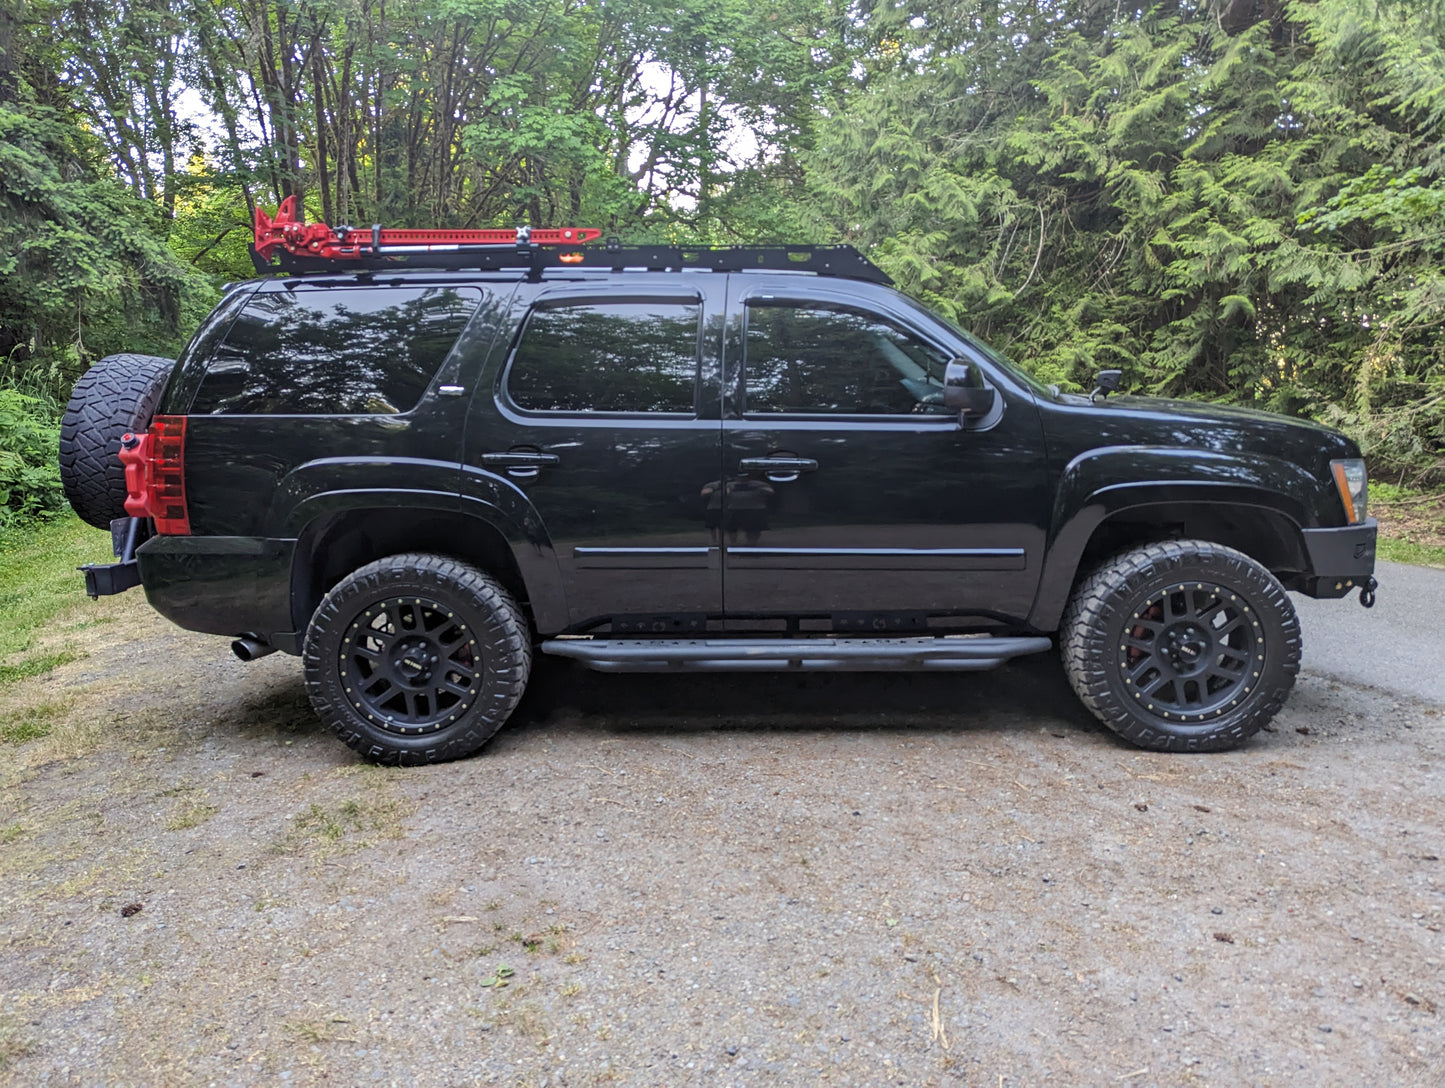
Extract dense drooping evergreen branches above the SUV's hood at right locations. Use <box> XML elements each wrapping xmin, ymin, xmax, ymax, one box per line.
<box><xmin>803</xmin><ymin>0</ymin><xmax>1445</xmax><ymax>480</ymax></box>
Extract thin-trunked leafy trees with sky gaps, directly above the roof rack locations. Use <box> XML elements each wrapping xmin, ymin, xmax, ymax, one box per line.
<box><xmin>159</xmin><ymin>0</ymin><xmax>848</xmax><ymax>237</ymax></box>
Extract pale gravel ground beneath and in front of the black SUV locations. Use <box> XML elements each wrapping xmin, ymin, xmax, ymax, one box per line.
<box><xmin>0</xmin><ymin>600</ymin><xmax>1445</xmax><ymax>1088</ymax></box>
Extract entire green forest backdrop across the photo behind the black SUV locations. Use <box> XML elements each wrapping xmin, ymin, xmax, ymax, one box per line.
<box><xmin>8</xmin><ymin>0</ymin><xmax>1445</xmax><ymax>499</ymax></box>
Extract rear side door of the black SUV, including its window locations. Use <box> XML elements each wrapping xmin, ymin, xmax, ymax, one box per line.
<box><xmin>465</xmin><ymin>273</ymin><xmax>725</xmax><ymax>633</ymax></box>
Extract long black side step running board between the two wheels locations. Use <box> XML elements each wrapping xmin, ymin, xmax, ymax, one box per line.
<box><xmin>542</xmin><ymin>637</ymin><xmax>1053</xmax><ymax>672</ymax></box>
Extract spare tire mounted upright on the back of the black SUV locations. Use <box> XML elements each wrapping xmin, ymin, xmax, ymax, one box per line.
<box><xmin>61</xmin><ymin>353</ymin><xmax>176</xmax><ymax>529</ymax></box>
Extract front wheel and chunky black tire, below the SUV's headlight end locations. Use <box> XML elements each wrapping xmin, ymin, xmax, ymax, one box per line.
<box><xmin>1059</xmin><ymin>540</ymin><xmax>1301</xmax><ymax>751</ymax></box>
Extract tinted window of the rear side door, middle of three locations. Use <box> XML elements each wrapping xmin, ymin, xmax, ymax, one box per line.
<box><xmin>507</xmin><ymin>302</ymin><xmax>701</xmax><ymax>415</ymax></box>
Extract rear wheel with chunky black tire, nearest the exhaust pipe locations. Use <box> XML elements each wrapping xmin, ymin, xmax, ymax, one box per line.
<box><xmin>302</xmin><ymin>555</ymin><xmax>532</xmax><ymax>764</ymax></box>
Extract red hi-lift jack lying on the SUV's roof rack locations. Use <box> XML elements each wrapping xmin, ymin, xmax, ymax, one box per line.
<box><xmin>256</xmin><ymin>197</ymin><xmax>601</xmax><ymax>263</ymax></box>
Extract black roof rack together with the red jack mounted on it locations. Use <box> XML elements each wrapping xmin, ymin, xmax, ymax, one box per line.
<box><xmin>251</xmin><ymin>197</ymin><xmax>893</xmax><ymax>285</ymax></box>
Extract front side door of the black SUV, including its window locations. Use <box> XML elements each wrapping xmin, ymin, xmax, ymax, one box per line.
<box><xmin>720</xmin><ymin>275</ymin><xmax>1048</xmax><ymax>631</ymax></box>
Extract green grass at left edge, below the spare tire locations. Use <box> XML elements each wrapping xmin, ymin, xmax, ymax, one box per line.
<box><xmin>0</xmin><ymin>513</ymin><xmax>111</xmax><ymax>658</ymax></box>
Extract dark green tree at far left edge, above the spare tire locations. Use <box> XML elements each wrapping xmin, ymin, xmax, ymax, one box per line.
<box><xmin>0</xmin><ymin>3</ymin><xmax>214</xmax><ymax>400</ymax></box>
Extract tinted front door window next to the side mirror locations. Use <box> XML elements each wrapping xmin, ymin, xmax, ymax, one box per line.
<box><xmin>744</xmin><ymin>303</ymin><xmax>948</xmax><ymax>416</ymax></box>
